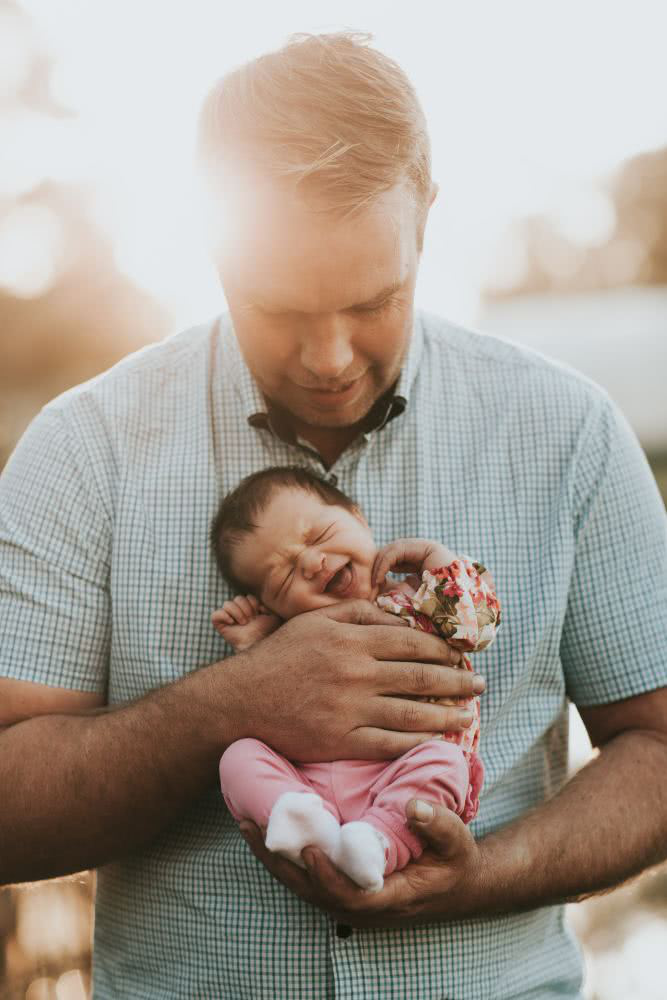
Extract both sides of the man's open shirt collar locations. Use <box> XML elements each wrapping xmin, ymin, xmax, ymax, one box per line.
<box><xmin>220</xmin><ymin>310</ymin><xmax>424</xmax><ymax>431</ymax></box>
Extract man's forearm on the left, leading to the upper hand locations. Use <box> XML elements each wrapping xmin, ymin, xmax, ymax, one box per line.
<box><xmin>0</xmin><ymin>665</ymin><xmax>245</xmax><ymax>884</ymax></box>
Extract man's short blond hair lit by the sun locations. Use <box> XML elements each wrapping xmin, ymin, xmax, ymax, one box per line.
<box><xmin>198</xmin><ymin>31</ymin><xmax>431</xmax><ymax>234</ymax></box>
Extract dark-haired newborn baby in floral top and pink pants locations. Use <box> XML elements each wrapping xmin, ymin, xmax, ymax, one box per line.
<box><xmin>211</xmin><ymin>466</ymin><xmax>500</xmax><ymax>892</ymax></box>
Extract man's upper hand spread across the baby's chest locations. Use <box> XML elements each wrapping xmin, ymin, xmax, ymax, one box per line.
<box><xmin>219</xmin><ymin>601</ymin><xmax>484</xmax><ymax>761</ymax></box>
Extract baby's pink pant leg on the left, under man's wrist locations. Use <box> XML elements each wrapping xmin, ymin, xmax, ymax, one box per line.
<box><xmin>220</xmin><ymin>739</ymin><xmax>340</xmax><ymax>830</ymax></box>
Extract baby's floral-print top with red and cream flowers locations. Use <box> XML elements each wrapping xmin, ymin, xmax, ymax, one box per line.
<box><xmin>377</xmin><ymin>556</ymin><xmax>500</xmax><ymax>756</ymax></box>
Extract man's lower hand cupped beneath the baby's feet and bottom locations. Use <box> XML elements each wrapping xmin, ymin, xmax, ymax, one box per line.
<box><xmin>241</xmin><ymin>799</ymin><xmax>483</xmax><ymax>927</ymax></box>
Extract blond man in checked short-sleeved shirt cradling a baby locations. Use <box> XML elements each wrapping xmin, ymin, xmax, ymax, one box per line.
<box><xmin>0</xmin><ymin>34</ymin><xmax>667</xmax><ymax>1000</ymax></box>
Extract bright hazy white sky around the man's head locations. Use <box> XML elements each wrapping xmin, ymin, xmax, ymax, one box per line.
<box><xmin>5</xmin><ymin>0</ymin><xmax>667</xmax><ymax>326</ymax></box>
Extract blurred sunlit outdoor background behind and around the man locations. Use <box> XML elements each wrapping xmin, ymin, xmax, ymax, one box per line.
<box><xmin>0</xmin><ymin>0</ymin><xmax>667</xmax><ymax>1000</ymax></box>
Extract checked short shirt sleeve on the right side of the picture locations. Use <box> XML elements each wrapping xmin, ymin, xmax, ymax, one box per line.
<box><xmin>560</xmin><ymin>397</ymin><xmax>667</xmax><ymax>706</ymax></box>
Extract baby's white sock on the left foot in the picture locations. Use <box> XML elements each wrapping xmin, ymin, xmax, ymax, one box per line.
<box><xmin>264</xmin><ymin>792</ymin><xmax>340</xmax><ymax>868</ymax></box>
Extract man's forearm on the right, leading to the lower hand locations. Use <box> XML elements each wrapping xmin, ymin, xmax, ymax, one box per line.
<box><xmin>473</xmin><ymin>731</ymin><xmax>667</xmax><ymax>914</ymax></box>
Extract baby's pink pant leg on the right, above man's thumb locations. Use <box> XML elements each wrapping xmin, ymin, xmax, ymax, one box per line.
<box><xmin>360</xmin><ymin>740</ymin><xmax>470</xmax><ymax>875</ymax></box>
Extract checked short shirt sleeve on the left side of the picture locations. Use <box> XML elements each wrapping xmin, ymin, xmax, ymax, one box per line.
<box><xmin>0</xmin><ymin>407</ymin><xmax>111</xmax><ymax>694</ymax></box>
